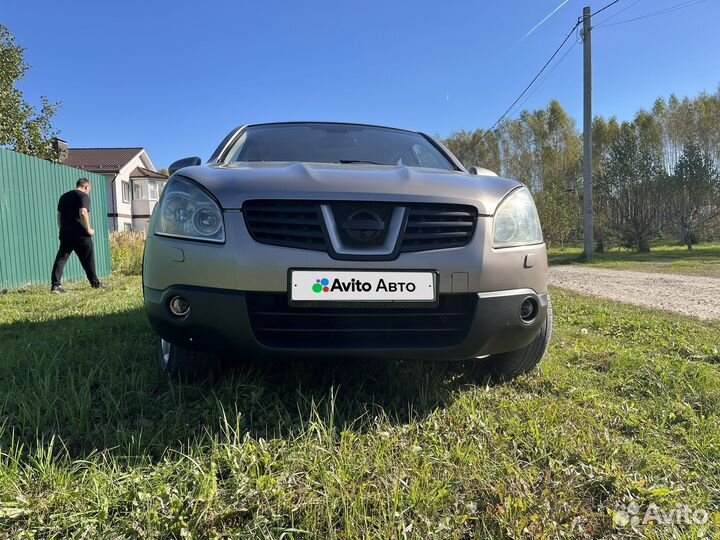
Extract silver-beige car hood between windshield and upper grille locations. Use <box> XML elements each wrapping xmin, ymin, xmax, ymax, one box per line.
<box><xmin>176</xmin><ymin>162</ymin><xmax>521</xmax><ymax>215</ymax></box>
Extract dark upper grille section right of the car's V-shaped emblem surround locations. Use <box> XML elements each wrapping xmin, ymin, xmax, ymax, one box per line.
<box><xmin>400</xmin><ymin>204</ymin><xmax>477</xmax><ymax>252</ymax></box>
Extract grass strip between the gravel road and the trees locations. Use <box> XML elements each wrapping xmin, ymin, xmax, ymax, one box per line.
<box><xmin>548</xmin><ymin>243</ymin><xmax>720</xmax><ymax>278</ymax></box>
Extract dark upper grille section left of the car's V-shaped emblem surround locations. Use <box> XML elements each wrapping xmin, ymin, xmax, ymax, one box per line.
<box><xmin>243</xmin><ymin>200</ymin><xmax>327</xmax><ymax>251</ymax></box>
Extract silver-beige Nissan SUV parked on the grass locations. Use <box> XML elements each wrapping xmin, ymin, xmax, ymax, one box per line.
<box><xmin>143</xmin><ymin>122</ymin><xmax>552</xmax><ymax>380</ymax></box>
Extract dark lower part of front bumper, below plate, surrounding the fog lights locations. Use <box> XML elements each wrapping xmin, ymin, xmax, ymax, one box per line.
<box><xmin>144</xmin><ymin>285</ymin><xmax>548</xmax><ymax>360</ymax></box>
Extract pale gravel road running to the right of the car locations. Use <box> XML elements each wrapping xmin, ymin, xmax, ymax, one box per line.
<box><xmin>549</xmin><ymin>265</ymin><xmax>720</xmax><ymax>319</ymax></box>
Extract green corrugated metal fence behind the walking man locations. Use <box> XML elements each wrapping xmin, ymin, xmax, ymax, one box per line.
<box><xmin>0</xmin><ymin>148</ymin><xmax>111</xmax><ymax>289</ymax></box>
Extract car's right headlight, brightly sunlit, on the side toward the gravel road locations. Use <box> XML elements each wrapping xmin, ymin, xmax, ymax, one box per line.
<box><xmin>493</xmin><ymin>188</ymin><xmax>543</xmax><ymax>248</ymax></box>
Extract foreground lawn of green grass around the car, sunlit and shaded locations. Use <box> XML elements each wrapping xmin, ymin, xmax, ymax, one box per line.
<box><xmin>0</xmin><ymin>277</ymin><xmax>720</xmax><ymax>539</ymax></box>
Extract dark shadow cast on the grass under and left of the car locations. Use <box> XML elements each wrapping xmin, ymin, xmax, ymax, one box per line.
<box><xmin>0</xmin><ymin>309</ymin><xmax>467</xmax><ymax>458</ymax></box>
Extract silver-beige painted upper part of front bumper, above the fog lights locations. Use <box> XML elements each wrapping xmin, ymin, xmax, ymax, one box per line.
<box><xmin>143</xmin><ymin>211</ymin><xmax>547</xmax><ymax>295</ymax></box>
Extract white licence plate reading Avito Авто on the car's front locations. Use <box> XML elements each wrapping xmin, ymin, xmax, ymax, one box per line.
<box><xmin>290</xmin><ymin>270</ymin><xmax>437</xmax><ymax>302</ymax></box>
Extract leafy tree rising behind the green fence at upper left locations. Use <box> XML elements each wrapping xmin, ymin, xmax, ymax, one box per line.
<box><xmin>0</xmin><ymin>25</ymin><xmax>59</xmax><ymax>160</ymax></box>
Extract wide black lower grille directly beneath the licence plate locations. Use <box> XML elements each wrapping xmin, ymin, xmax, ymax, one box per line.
<box><xmin>246</xmin><ymin>293</ymin><xmax>477</xmax><ymax>349</ymax></box>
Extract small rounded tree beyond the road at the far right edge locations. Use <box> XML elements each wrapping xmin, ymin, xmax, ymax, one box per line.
<box><xmin>665</xmin><ymin>144</ymin><xmax>720</xmax><ymax>250</ymax></box>
